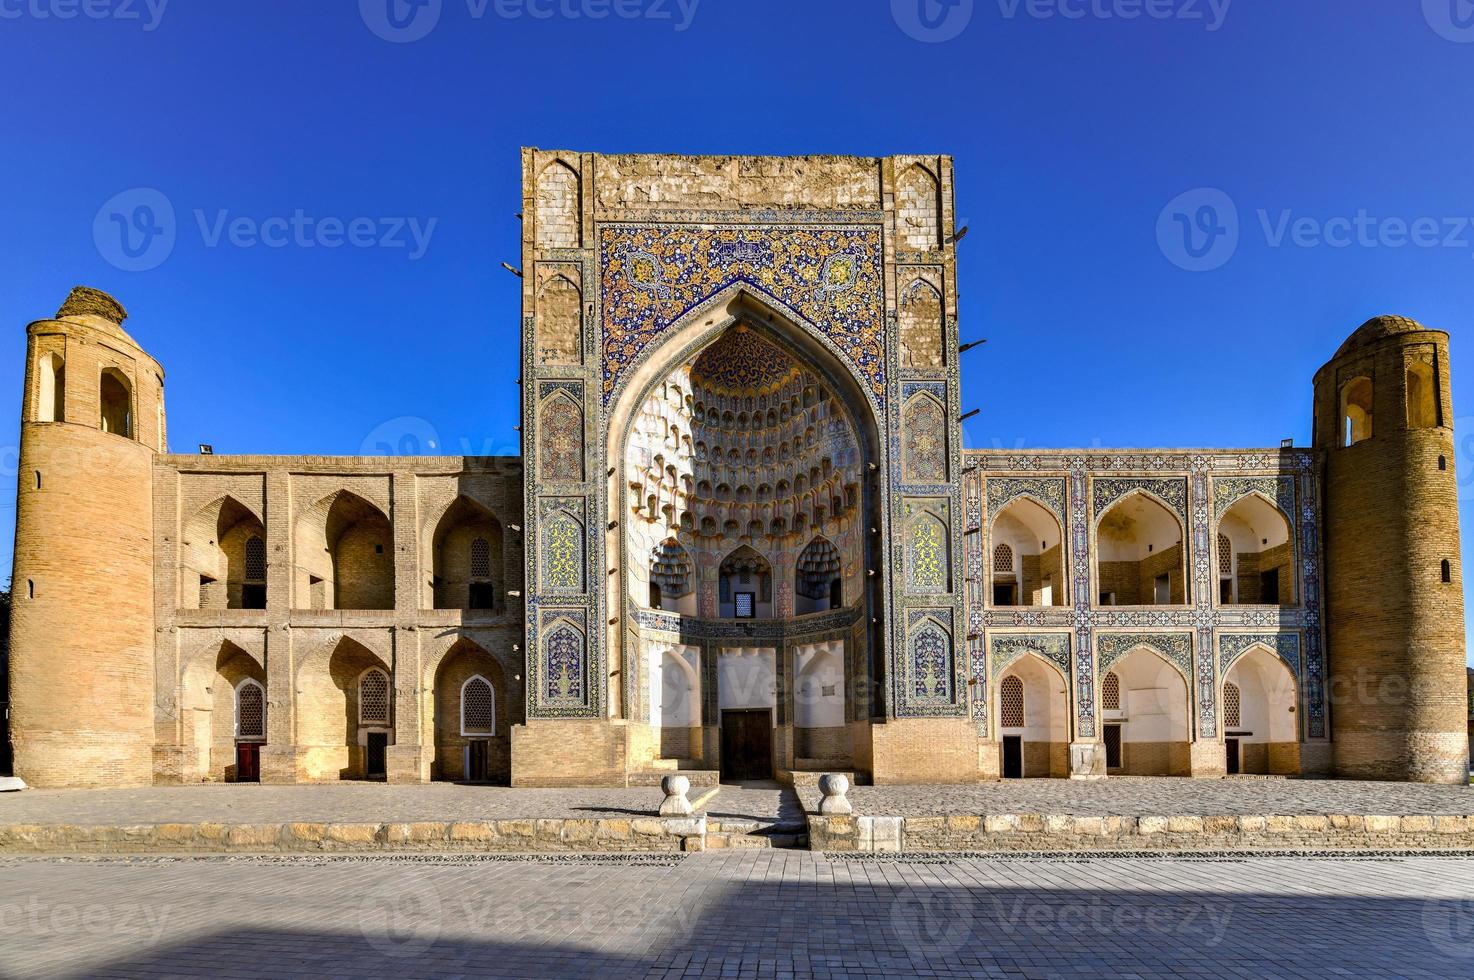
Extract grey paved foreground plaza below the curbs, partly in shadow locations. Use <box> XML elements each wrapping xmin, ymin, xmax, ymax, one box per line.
<box><xmin>0</xmin><ymin>852</ymin><xmax>1474</xmax><ymax>979</ymax></box>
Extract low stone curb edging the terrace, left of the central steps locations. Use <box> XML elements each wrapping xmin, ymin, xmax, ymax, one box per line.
<box><xmin>0</xmin><ymin>816</ymin><xmax>706</xmax><ymax>855</ymax></box>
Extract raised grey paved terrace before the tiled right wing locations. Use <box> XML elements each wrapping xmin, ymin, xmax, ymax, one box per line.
<box><xmin>849</xmin><ymin>777</ymin><xmax>1474</xmax><ymax>816</ymax></box>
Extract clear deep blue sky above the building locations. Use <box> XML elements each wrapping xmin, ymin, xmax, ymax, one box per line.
<box><xmin>0</xmin><ymin>0</ymin><xmax>1474</xmax><ymax>666</ymax></box>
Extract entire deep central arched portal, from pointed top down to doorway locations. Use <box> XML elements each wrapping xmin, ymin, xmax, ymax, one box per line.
<box><xmin>607</xmin><ymin>295</ymin><xmax>884</xmax><ymax>772</ymax></box>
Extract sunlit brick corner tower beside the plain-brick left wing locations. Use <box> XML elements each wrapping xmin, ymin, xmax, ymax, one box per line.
<box><xmin>10</xmin><ymin>287</ymin><xmax>165</xmax><ymax>787</ymax></box>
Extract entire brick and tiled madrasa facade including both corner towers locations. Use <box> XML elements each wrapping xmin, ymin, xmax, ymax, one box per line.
<box><xmin>10</xmin><ymin>149</ymin><xmax>1468</xmax><ymax>787</ymax></box>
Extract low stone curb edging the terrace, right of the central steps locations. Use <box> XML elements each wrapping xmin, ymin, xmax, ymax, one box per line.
<box><xmin>808</xmin><ymin>813</ymin><xmax>1474</xmax><ymax>853</ymax></box>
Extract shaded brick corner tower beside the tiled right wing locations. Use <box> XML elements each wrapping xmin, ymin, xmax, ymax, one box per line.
<box><xmin>1315</xmin><ymin>317</ymin><xmax>1468</xmax><ymax>784</ymax></box>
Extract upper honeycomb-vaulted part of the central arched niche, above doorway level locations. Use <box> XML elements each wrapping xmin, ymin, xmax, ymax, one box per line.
<box><xmin>606</xmin><ymin>287</ymin><xmax>886</xmax><ymax>724</ymax></box>
